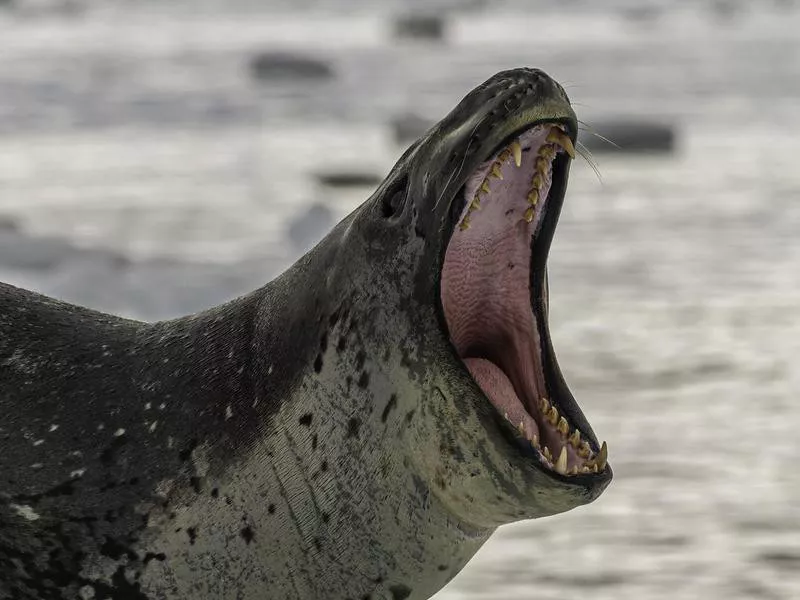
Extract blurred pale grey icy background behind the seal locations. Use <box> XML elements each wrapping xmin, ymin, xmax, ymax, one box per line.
<box><xmin>0</xmin><ymin>0</ymin><xmax>800</xmax><ymax>600</ymax></box>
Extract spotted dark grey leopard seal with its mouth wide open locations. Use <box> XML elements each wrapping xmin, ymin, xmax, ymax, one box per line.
<box><xmin>0</xmin><ymin>68</ymin><xmax>612</xmax><ymax>600</ymax></box>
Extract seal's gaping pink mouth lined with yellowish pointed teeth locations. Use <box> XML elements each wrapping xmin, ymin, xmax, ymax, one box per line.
<box><xmin>441</xmin><ymin>123</ymin><xmax>607</xmax><ymax>476</ymax></box>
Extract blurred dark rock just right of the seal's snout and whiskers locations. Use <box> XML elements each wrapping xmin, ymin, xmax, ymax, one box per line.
<box><xmin>578</xmin><ymin>120</ymin><xmax>676</xmax><ymax>154</ymax></box>
